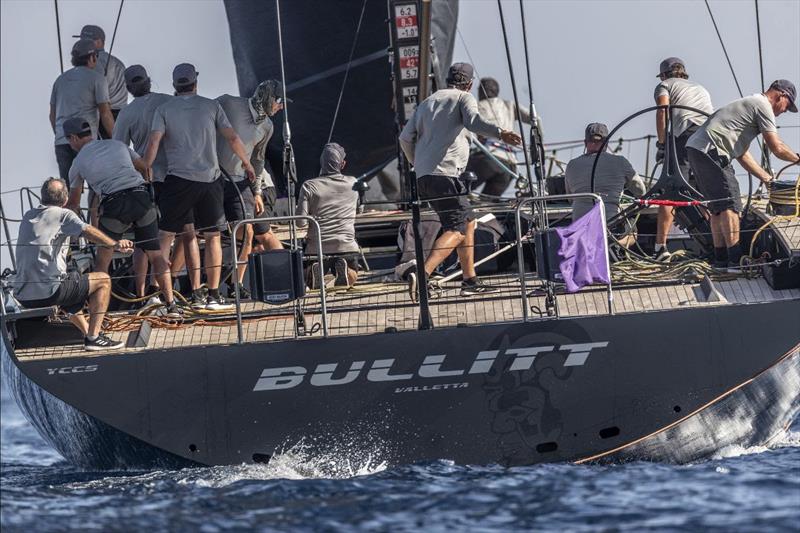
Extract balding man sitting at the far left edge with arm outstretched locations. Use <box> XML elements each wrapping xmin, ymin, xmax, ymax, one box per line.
<box><xmin>11</xmin><ymin>179</ymin><xmax>133</xmax><ymax>351</ymax></box>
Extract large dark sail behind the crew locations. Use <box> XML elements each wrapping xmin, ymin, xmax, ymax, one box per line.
<box><xmin>225</xmin><ymin>0</ymin><xmax>458</xmax><ymax>191</ymax></box>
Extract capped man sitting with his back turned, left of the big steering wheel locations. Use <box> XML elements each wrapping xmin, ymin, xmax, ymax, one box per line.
<box><xmin>564</xmin><ymin>122</ymin><xmax>645</xmax><ymax>246</ymax></box>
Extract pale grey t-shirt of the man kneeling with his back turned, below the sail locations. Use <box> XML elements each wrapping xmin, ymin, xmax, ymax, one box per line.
<box><xmin>297</xmin><ymin>174</ymin><xmax>358</xmax><ymax>255</ymax></box>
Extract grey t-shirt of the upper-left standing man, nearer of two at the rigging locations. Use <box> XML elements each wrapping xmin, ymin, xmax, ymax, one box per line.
<box><xmin>50</xmin><ymin>67</ymin><xmax>109</xmax><ymax>144</ymax></box>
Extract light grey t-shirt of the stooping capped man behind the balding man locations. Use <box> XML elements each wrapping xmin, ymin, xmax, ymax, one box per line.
<box><xmin>69</xmin><ymin>139</ymin><xmax>144</xmax><ymax>196</ymax></box>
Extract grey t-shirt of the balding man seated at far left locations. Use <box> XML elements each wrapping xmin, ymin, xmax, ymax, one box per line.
<box><xmin>11</xmin><ymin>205</ymin><xmax>87</xmax><ymax>300</ymax></box>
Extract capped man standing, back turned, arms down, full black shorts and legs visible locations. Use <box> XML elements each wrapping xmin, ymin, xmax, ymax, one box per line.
<box><xmin>145</xmin><ymin>63</ymin><xmax>255</xmax><ymax>311</ymax></box>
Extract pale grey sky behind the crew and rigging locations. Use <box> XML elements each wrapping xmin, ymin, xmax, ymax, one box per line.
<box><xmin>0</xmin><ymin>0</ymin><xmax>800</xmax><ymax>264</ymax></box>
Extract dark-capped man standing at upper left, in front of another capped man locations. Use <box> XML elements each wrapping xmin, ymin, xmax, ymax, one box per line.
<box><xmin>50</xmin><ymin>39</ymin><xmax>114</xmax><ymax>186</ymax></box>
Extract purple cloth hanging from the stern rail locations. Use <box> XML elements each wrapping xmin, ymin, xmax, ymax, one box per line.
<box><xmin>555</xmin><ymin>203</ymin><xmax>610</xmax><ymax>292</ymax></box>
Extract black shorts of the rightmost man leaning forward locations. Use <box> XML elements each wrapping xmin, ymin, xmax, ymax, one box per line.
<box><xmin>687</xmin><ymin>147</ymin><xmax>742</xmax><ymax>215</ymax></box>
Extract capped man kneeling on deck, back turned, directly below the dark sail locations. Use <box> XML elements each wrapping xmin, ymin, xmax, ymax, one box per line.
<box><xmin>296</xmin><ymin>143</ymin><xmax>359</xmax><ymax>288</ymax></box>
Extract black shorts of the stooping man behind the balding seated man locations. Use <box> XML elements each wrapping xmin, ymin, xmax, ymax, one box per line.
<box><xmin>99</xmin><ymin>188</ymin><xmax>160</xmax><ymax>250</ymax></box>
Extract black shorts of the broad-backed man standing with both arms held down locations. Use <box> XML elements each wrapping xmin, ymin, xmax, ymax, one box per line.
<box><xmin>158</xmin><ymin>174</ymin><xmax>225</xmax><ymax>233</ymax></box>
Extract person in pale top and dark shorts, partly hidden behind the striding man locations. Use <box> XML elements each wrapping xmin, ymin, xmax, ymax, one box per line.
<box><xmin>467</xmin><ymin>78</ymin><xmax>531</xmax><ymax>196</ymax></box>
